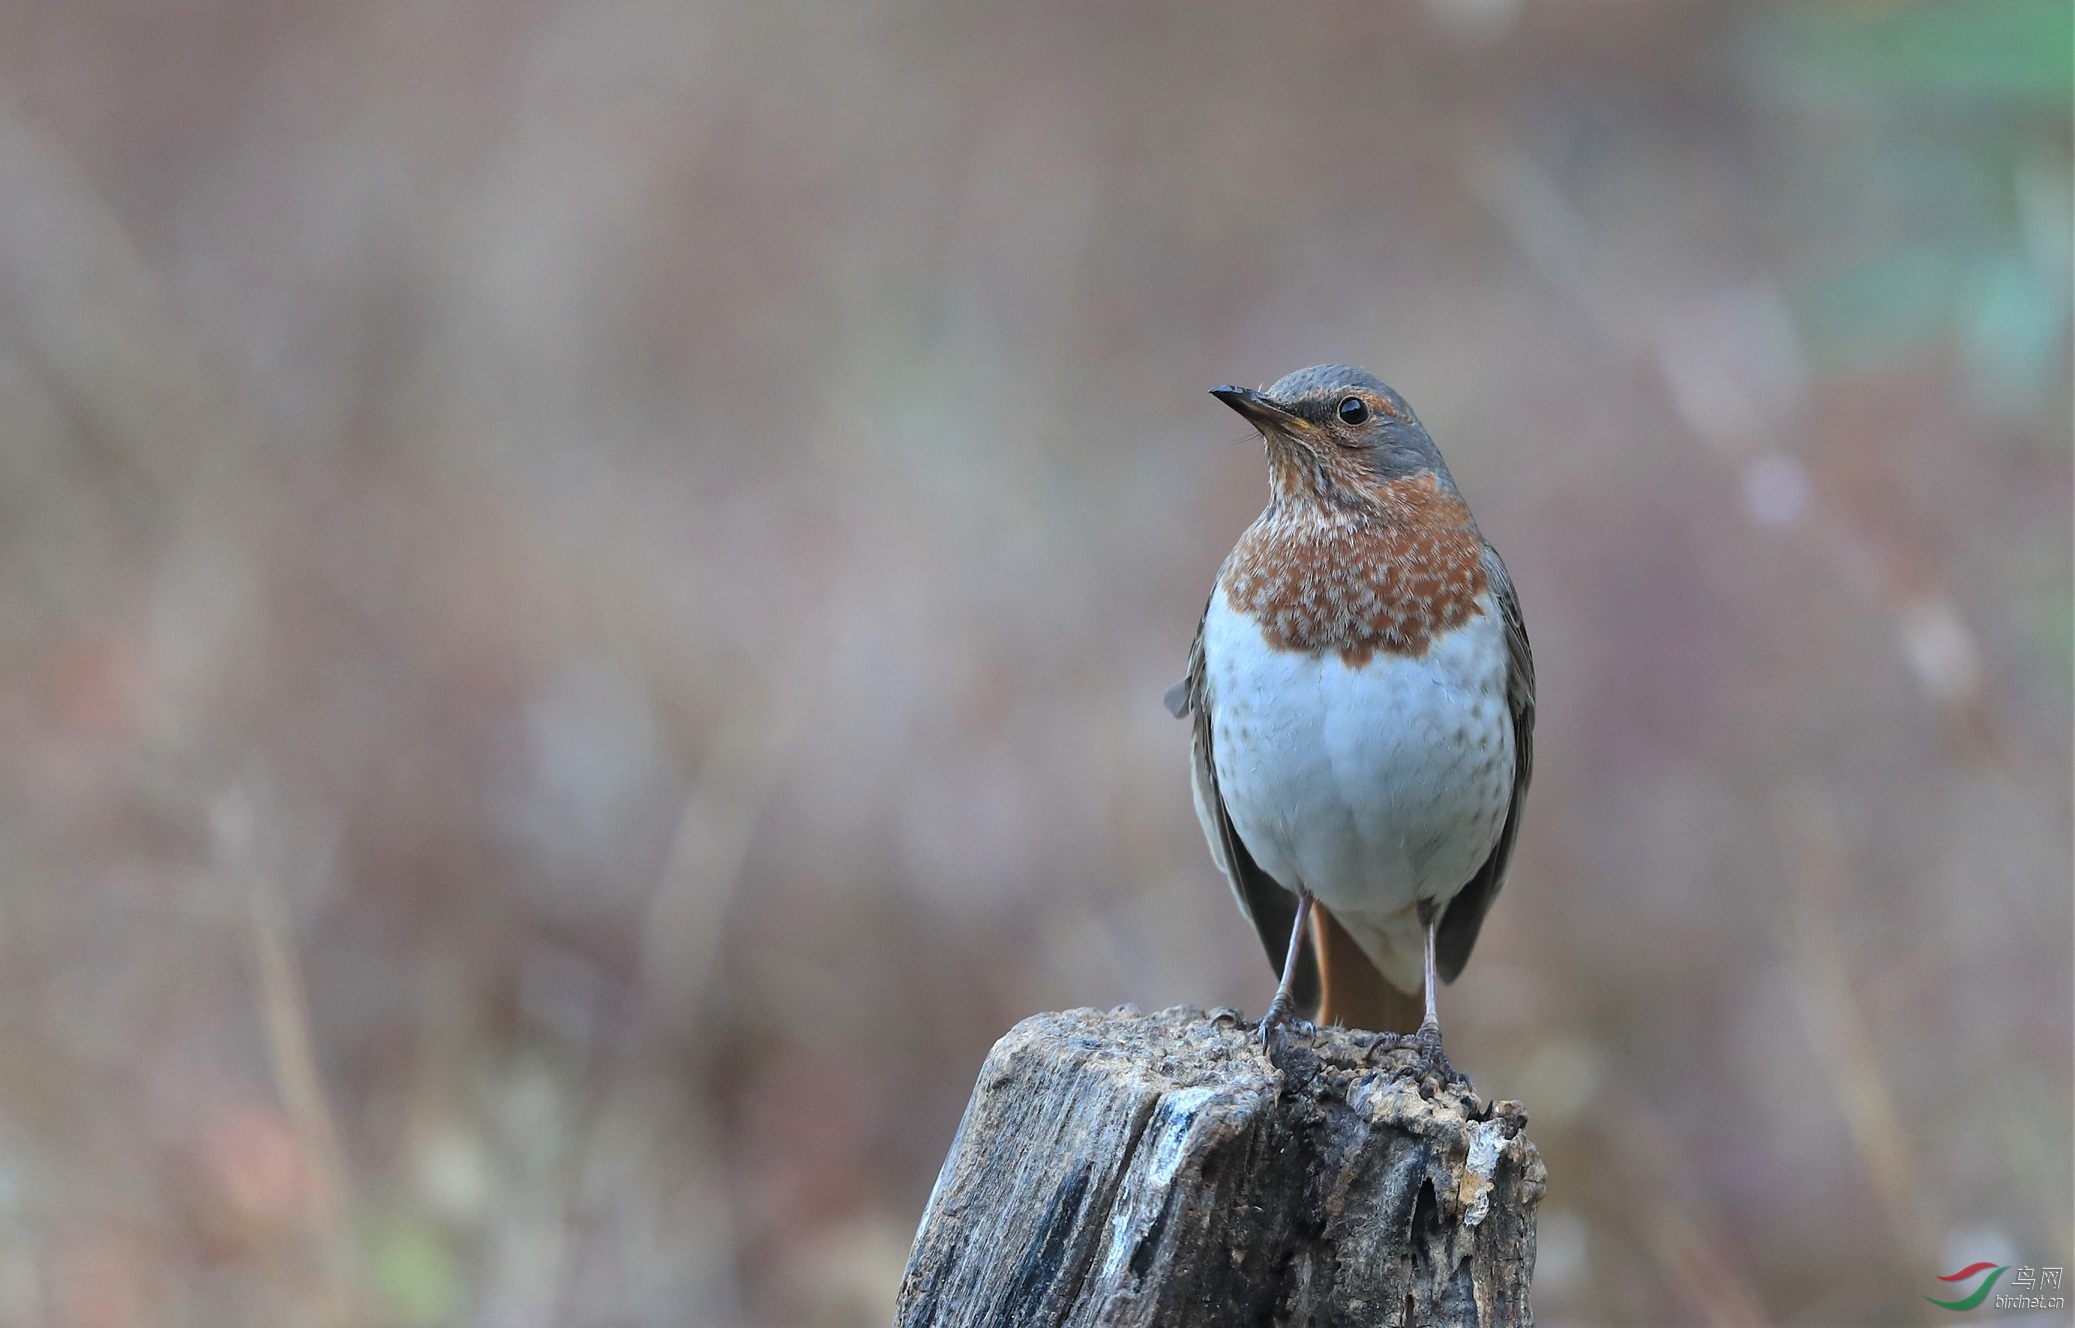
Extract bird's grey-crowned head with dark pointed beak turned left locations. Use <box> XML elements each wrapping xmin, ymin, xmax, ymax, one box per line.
<box><xmin>1210</xmin><ymin>365</ymin><xmax>1455</xmax><ymax>500</ymax></box>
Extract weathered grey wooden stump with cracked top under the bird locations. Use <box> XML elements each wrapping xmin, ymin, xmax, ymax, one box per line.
<box><xmin>894</xmin><ymin>1006</ymin><xmax>1548</xmax><ymax>1328</ymax></box>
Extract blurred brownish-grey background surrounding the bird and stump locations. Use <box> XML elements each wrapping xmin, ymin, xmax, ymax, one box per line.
<box><xmin>0</xmin><ymin>0</ymin><xmax>2075</xmax><ymax>1328</ymax></box>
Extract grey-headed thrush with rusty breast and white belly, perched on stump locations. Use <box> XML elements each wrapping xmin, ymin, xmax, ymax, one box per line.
<box><xmin>1166</xmin><ymin>356</ymin><xmax>1536</xmax><ymax>1075</ymax></box>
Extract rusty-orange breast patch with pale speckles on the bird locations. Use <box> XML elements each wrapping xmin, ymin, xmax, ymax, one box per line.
<box><xmin>1224</xmin><ymin>471</ymin><xmax>1486</xmax><ymax>668</ymax></box>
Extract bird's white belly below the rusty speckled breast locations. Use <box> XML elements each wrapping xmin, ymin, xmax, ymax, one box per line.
<box><xmin>1204</xmin><ymin>589</ymin><xmax>1513</xmax><ymax>990</ymax></box>
